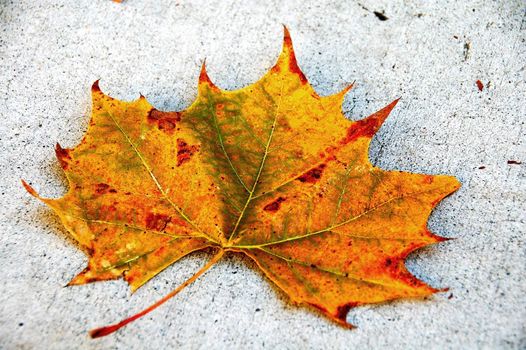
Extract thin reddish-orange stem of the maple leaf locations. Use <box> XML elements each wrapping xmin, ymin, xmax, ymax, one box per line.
<box><xmin>89</xmin><ymin>249</ymin><xmax>225</xmax><ymax>338</ymax></box>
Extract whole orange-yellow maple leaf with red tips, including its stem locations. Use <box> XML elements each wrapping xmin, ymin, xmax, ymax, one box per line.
<box><xmin>24</xmin><ymin>28</ymin><xmax>460</xmax><ymax>337</ymax></box>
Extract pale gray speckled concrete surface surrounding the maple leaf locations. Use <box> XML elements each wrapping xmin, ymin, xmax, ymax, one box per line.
<box><xmin>0</xmin><ymin>0</ymin><xmax>526</xmax><ymax>349</ymax></box>
